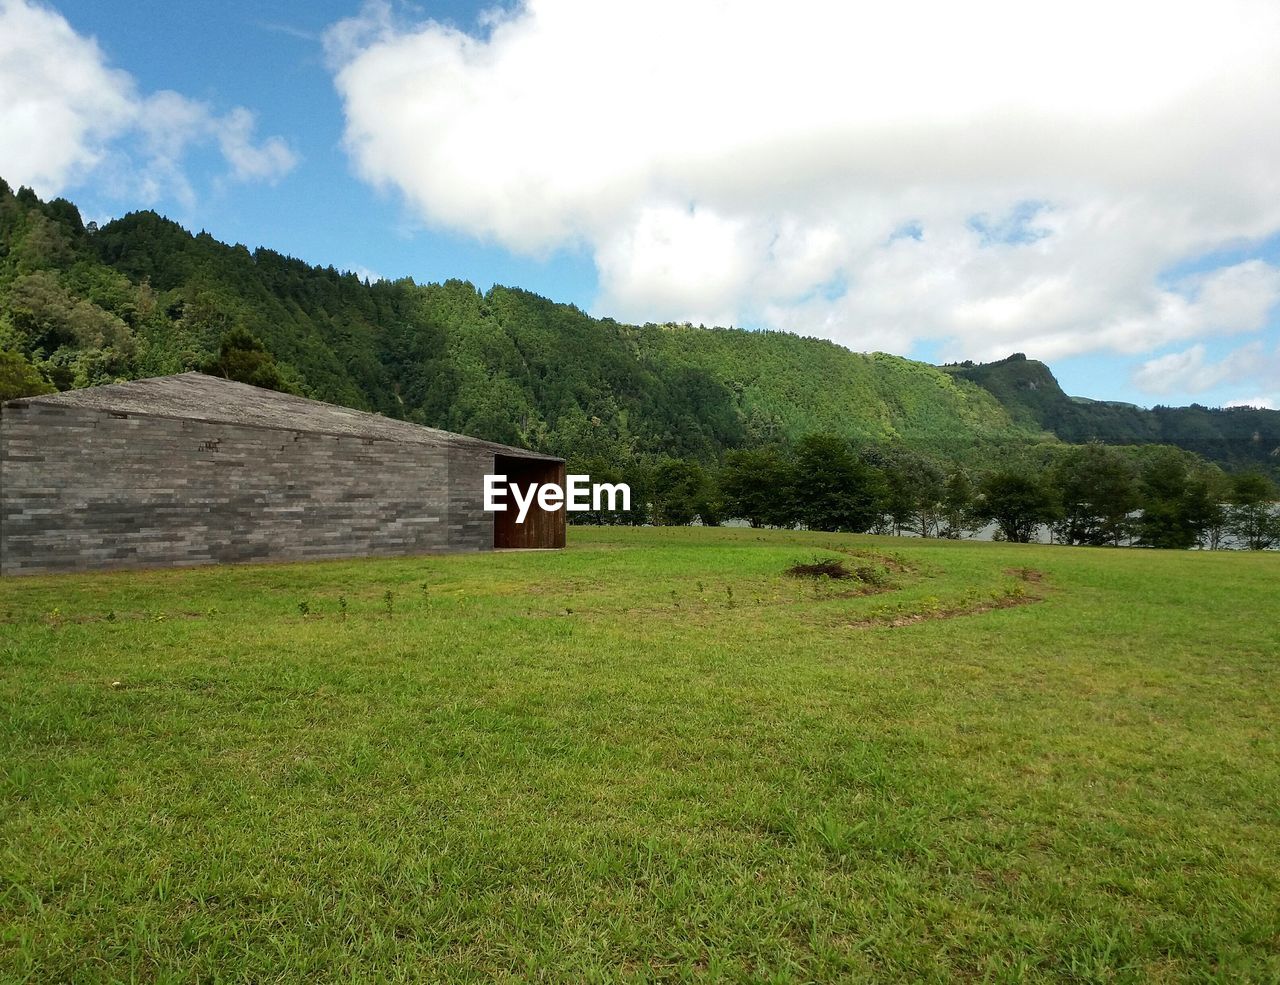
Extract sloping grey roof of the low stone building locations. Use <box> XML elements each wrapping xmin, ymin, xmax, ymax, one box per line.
<box><xmin>6</xmin><ymin>372</ymin><xmax>561</xmax><ymax>462</ymax></box>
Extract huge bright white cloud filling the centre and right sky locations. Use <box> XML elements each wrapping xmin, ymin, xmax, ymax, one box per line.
<box><xmin>328</xmin><ymin>0</ymin><xmax>1280</xmax><ymax>358</ymax></box>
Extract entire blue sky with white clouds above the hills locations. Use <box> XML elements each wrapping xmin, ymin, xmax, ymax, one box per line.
<box><xmin>0</xmin><ymin>0</ymin><xmax>1280</xmax><ymax>407</ymax></box>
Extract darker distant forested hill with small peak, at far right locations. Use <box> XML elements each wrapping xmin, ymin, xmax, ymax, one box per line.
<box><xmin>943</xmin><ymin>353</ymin><xmax>1280</xmax><ymax>468</ymax></box>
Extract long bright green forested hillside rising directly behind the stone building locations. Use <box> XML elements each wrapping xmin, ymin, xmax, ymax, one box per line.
<box><xmin>0</xmin><ymin>182</ymin><xmax>1280</xmax><ymax>475</ymax></box>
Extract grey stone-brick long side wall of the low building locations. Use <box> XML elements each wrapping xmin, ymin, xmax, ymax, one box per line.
<box><xmin>0</xmin><ymin>402</ymin><xmax>493</xmax><ymax>574</ymax></box>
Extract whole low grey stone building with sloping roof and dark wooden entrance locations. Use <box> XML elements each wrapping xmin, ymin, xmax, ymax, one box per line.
<box><xmin>0</xmin><ymin>372</ymin><xmax>564</xmax><ymax>574</ymax></box>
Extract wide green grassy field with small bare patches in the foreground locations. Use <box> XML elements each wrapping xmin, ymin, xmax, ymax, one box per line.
<box><xmin>0</xmin><ymin>530</ymin><xmax>1280</xmax><ymax>982</ymax></box>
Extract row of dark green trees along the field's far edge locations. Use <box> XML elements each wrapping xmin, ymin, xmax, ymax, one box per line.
<box><xmin>570</xmin><ymin>434</ymin><xmax>1280</xmax><ymax>550</ymax></box>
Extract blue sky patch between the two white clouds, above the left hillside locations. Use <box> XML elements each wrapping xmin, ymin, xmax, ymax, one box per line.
<box><xmin>49</xmin><ymin>0</ymin><xmax>595</xmax><ymax>306</ymax></box>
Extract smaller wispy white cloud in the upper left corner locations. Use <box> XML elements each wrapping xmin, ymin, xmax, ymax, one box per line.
<box><xmin>0</xmin><ymin>0</ymin><xmax>297</xmax><ymax>202</ymax></box>
